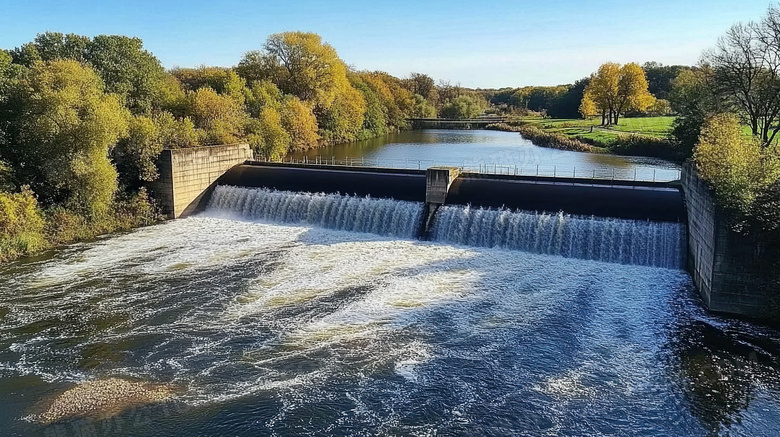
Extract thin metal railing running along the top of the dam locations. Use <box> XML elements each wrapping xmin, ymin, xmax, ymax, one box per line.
<box><xmin>256</xmin><ymin>156</ymin><xmax>681</xmax><ymax>182</ymax></box>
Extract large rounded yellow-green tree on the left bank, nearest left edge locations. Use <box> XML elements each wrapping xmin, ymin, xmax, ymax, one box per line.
<box><xmin>0</xmin><ymin>60</ymin><xmax>127</xmax><ymax>214</ymax></box>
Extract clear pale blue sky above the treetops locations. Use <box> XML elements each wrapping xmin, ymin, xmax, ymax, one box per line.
<box><xmin>0</xmin><ymin>0</ymin><xmax>770</xmax><ymax>88</ymax></box>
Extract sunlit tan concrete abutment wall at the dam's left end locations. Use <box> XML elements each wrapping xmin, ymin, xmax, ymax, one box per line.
<box><xmin>152</xmin><ymin>144</ymin><xmax>253</xmax><ymax>218</ymax></box>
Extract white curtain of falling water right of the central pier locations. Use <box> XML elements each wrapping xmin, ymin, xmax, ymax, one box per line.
<box><xmin>431</xmin><ymin>206</ymin><xmax>685</xmax><ymax>269</ymax></box>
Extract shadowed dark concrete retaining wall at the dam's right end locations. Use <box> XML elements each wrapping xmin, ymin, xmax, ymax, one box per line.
<box><xmin>683</xmin><ymin>164</ymin><xmax>778</xmax><ymax>319</ymax></box>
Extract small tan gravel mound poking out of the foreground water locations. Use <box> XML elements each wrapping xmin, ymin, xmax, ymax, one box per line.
<box><xmin>31</xmin><ymin>378</ymin><xmax>175</xmax><ymax>423</ymax></box>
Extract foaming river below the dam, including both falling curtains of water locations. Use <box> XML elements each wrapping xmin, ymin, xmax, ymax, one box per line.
<box><xmin>0</xmin><ymin>187</ymin><xmax>780</xmax><ymax>436</ymax></box>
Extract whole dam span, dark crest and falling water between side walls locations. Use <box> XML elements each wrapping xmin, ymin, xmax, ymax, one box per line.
<box><xmin>209</xmin><ymin>162</ymin><xmax>685</xmax><ymax>268</ymax></box>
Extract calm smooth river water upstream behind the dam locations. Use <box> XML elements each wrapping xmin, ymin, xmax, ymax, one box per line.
<box><xmin>287</xmin><ymin>129</ymin><xmax>680</xmax><ymax>181</ymax></box>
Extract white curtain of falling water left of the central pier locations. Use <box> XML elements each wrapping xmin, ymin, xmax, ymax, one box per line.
<box><xmin>207</xmin><ymin>185</ymin><xmax>423</xmax><ymax>239</ymax></box>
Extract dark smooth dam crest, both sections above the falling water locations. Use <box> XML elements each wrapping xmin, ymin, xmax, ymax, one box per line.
<box><xmin>217</xmin><ymin>163</ymin><xmax>686</xmax><ymax>222</ymax></box>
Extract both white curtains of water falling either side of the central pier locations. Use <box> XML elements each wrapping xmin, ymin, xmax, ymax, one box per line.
<box><xmin>208</xmin><ymin>186</ymin><xmax>685</xmax><ymax>268</ymax></box>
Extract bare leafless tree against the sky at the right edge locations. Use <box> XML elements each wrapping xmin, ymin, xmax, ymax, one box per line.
<box><xmin>703</xmin><ymin>7</ymin><xmax>780</xmax><ymax>146</ymax></box>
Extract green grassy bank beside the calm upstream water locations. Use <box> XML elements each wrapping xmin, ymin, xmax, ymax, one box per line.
<box><xmin>490</xmin><ymin>117</ymin><xmax>684</xmax><ymax>161</ymax></box>
